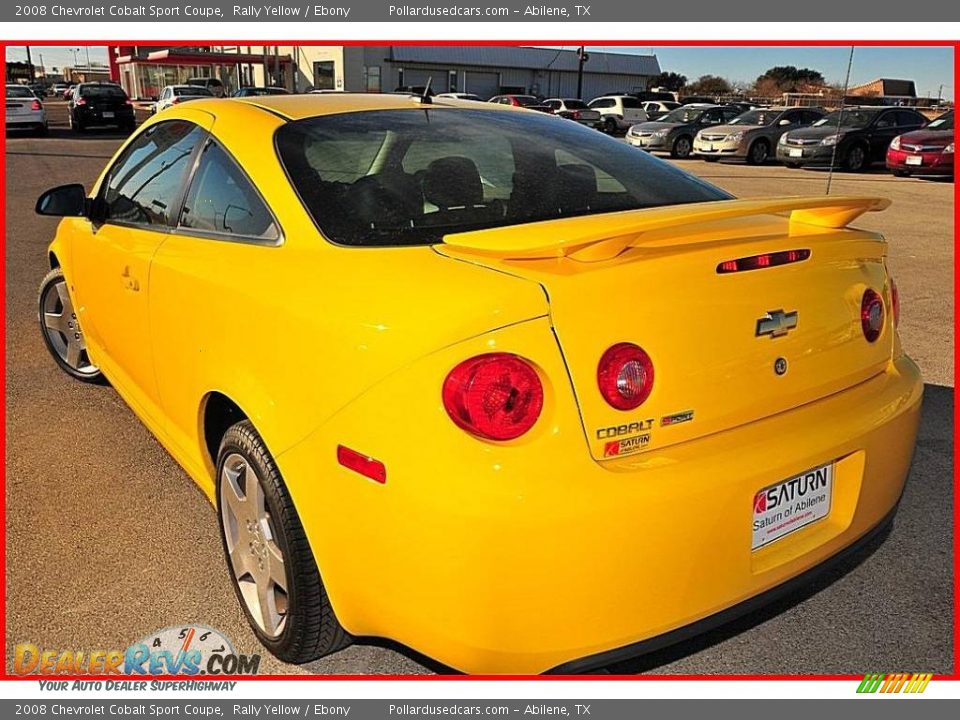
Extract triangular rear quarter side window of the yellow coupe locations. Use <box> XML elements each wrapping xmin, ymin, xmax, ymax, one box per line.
<box><xmin>180</xmin><ymin>140</ymin><xmax>280</xmax><ymax>242</ymax></box>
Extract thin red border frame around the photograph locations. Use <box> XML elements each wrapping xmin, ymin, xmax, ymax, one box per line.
<box><xmin>0</xmin><ymin>38</ymin><xmax>960</xmax><ymax>682</ymax></box>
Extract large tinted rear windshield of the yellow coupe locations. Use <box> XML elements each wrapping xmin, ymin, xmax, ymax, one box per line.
<box><xmin>276</xmin><ymin>107</ymin><xmax>730</xmax><ymax>246</ymax></box>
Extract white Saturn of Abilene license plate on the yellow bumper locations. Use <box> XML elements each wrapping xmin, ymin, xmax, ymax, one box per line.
<box><xmin>750</xmin><ymin>463</ymin><xmax>833</xmax><ymax>550</ymax></box>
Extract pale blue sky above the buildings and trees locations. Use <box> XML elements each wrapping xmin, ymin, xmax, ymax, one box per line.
<box><xmin>7</xmin><ymin>43</ymin><xmax>953</xmax><ymax>100</ymax></box>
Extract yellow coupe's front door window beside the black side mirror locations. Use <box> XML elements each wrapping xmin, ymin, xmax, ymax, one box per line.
<box><xmin>101</xmin><ymin>120</ymin><xmax>205</xmax><ymax>226</ymax></box>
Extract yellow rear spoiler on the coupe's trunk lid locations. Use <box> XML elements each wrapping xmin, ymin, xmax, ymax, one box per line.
<box><xmin>443</xmin><ymin>196</ymin><xmax>890</xmax><ymax>262</ymax></box>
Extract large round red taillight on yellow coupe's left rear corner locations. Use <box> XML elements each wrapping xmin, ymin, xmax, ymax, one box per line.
<box><xmin>443</xmin><ymin>353</ymin><xmax>543</xmax><ymax>440</ymax></box>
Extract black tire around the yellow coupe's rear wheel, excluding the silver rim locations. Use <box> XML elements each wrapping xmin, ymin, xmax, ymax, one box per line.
<box><xmin>216</xmin><ymin>420</ymin><xmax>353</xmax><ymax>664</ymax></box>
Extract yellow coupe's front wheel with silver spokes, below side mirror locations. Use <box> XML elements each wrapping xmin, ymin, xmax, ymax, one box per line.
<box><xmin>38</xmin><ymin>268</ymin><xmax>103</xmax><ymax>383</ymax></box>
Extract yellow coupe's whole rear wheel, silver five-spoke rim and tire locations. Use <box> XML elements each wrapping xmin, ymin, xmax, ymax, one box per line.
<box><xmin>217</xmin><ymin>420</ymin><xmax>351</xmax><ymax>663</ymax></box>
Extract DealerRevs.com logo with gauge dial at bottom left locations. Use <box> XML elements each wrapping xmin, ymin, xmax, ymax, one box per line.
<box><xmin>13</xmin><ymin>625</ymin><xmax>260</xmax><ymax>677</ymax></box>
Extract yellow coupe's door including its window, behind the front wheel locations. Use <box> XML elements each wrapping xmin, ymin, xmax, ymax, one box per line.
<box><xmin>71</xmin><ymin>113</ymin><xmax>206</xmax><ymax>414</ymax></box>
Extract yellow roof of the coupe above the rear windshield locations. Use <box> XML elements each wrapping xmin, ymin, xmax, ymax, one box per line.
<box><xmin>220</xmin><ymin>92</ymin><xmax>523</xmax><ymax>120</ymax></box>
